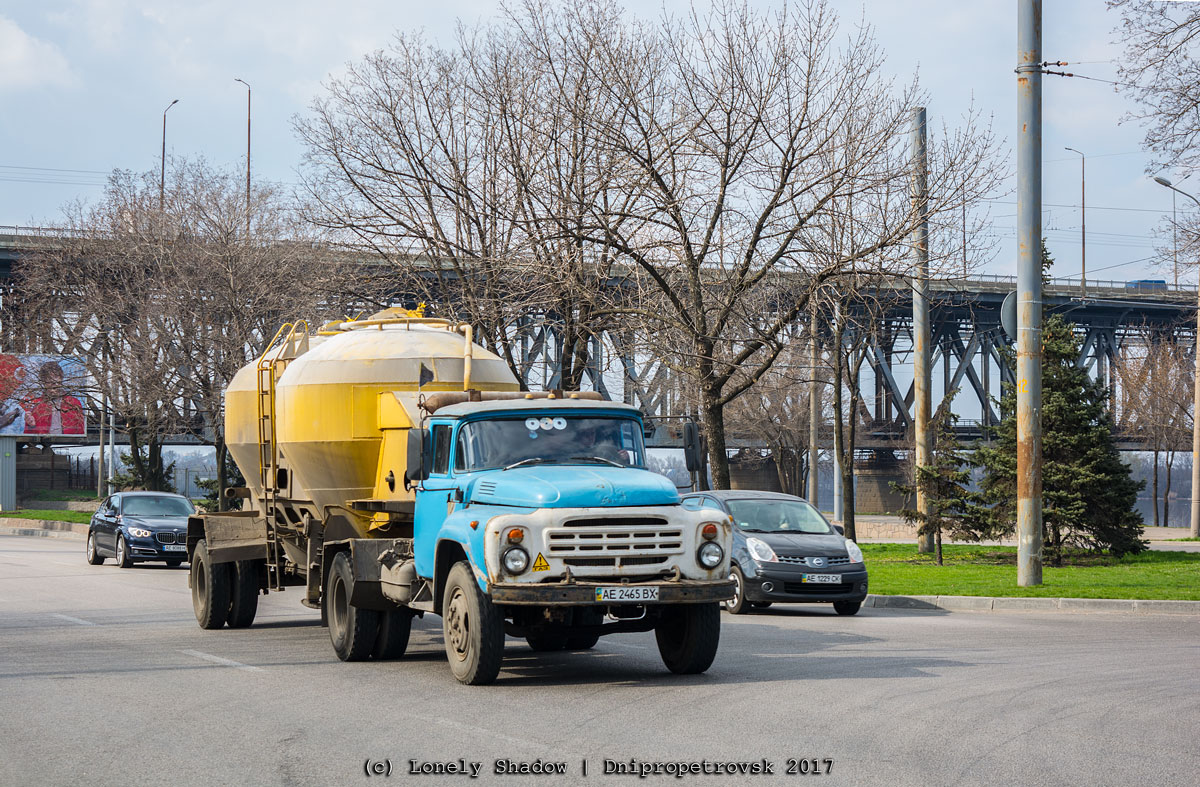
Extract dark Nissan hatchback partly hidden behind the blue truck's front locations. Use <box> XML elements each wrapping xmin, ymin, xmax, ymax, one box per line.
<box><xmin>683</xmin><ymin>489</ymin><xmax>866</xmax><ymax>615</ymax></box>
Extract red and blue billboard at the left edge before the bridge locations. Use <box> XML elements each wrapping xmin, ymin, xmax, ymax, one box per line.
<box><xmin>0</xmin><ymin>353</ymin><xmax>88</xmax><ymax>437</ymax></box>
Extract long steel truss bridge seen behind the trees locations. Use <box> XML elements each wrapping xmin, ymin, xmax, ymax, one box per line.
<box><xmin>0</xmin><ymin>227</ymin><xmax>1196</xmax><ymax>451</ymax></box>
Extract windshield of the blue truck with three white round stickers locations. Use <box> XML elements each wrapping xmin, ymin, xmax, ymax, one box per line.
<box><xmin>455</xmin><ymin>415</ymin><xmax>646</xmax><ymax>471</ymax></box>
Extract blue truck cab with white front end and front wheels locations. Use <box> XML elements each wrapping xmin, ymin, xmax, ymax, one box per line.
<box><xmin>413</xmin><ymin>398</ymin><xmax>732</xmax><ymax>683</ymax></box>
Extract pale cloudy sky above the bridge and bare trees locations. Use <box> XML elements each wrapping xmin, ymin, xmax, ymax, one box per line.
<box><xmin>0</xmin><ymin>0</ymin><xmax>1180</xmax><ymax>281</ymax></box>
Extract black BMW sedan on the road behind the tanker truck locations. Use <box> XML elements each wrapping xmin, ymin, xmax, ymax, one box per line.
<box><xmin>88</xmin><ymin>492</ymin><xmax>196</xmax><ymax>569</ymax></box>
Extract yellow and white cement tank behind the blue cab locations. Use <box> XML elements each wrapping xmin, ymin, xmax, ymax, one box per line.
<box><xmin>226</xmin><ymin>308</ymin><xmax>520</xmax><ymax>535</ymax></box>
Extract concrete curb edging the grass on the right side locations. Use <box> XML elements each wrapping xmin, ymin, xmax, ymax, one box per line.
<box><xmin>863</xmin><ymin>594</ymin><xmax>1200</xmax><ymax>615</ymax></box>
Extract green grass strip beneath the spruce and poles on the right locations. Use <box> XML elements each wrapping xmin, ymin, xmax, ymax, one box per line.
<box><xmin>862</xmin><ymin>543</ymin><xmax>1200</xmax><ymax>600</ymax></box>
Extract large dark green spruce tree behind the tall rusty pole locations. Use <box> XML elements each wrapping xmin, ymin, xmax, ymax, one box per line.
<box><xmin>974</xmin><ymin>314</ymin><xmax>1146</xmax><ymax>565</ymax></box>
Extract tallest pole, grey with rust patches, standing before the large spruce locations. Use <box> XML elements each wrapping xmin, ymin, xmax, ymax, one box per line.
<box><xmin>1016</xmin><ymin>0</ymin><xmax>1043</xmax><ymax>588</ymax></box>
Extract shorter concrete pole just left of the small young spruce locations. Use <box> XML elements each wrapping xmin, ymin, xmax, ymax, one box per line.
<box><xmin>910</xmin><ymin>107</ymin><xmax>934</xmax><ymax>552</ymax></box>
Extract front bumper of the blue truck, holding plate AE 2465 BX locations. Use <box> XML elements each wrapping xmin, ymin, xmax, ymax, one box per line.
<box><xmin>488</xmin><ymin>579</ymin><xmax>734</xmax><ymax>607</ymax></box>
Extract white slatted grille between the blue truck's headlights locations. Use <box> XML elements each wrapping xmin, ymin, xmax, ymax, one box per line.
<box><xmin>546</xmin><ymin>517</ymin><xmax>683</xmax><ymax>566</ymax></box>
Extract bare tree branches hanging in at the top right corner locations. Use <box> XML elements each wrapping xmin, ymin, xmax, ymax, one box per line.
<box><xmin>1109</xmin><ymin>0</ymin><xmax>1200</xmax><ymax>173</ymax></box>
